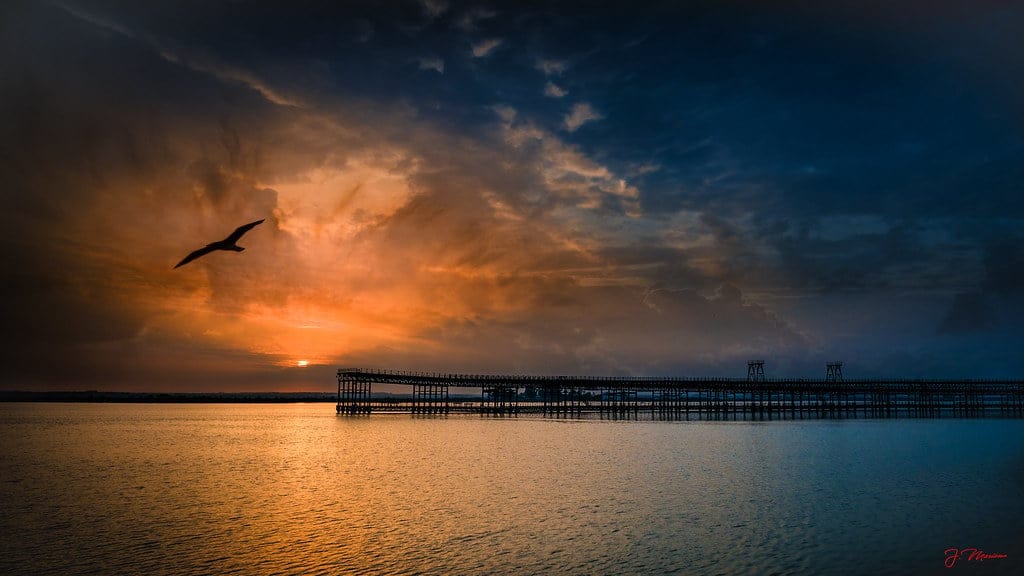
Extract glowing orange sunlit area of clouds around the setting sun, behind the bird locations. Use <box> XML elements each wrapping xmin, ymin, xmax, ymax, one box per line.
<box><xmin>16</xmin><ymin>98</ymin><xmax>796</xmax><ymax>385</ymax></box>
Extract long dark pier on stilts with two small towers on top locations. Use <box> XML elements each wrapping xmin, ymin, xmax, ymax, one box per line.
<box><xmin>337</xmin><ymin>363</ymin><xmax>1024</xmax><ymax>420</ymax></box>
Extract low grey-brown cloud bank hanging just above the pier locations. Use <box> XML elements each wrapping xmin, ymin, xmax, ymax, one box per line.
<box><xmin>359</xmin><ymin>279</ymin><xmax>808</xmax><ymax>376</ymax></box>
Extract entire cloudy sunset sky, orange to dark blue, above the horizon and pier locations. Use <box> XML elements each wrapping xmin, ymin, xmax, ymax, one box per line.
<box><xmin>0</xmin><ymin>0</ymin><xmax>1024</xmax><ymax>392</ymax></box>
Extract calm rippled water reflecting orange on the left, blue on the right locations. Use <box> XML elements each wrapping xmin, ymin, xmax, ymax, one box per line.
<box><xmin>0</xmin><ymin>404</ymin><xmax>1024</xmax><ymax>575</ymax></box>
